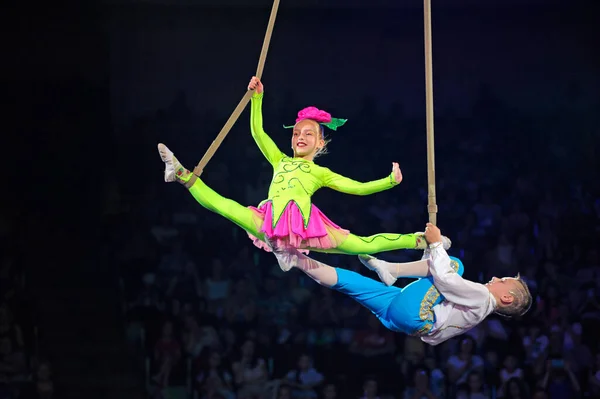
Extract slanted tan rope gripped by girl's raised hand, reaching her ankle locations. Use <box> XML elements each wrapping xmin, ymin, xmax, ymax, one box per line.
<box><xmin>194</xmin><ymin>0</ymin><xmax>280</xmax><ymax>177</ymax></box>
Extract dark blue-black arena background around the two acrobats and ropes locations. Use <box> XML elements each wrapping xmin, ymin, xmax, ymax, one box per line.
<box><xmin>0</xmin><ymin>0</ymin><xmax>600</xmax><ymax>398</ymax></box>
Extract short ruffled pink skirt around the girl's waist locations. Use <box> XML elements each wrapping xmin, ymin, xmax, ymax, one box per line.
<box><xmin>248</xmin><ymin>201</ymin><xmax>350</xmax><ymax>253</ymax></box>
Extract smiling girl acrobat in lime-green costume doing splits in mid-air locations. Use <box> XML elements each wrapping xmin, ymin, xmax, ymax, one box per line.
<box><xmin>158</xmin><ymin>77</ymin><xmax>448</xmax><ymax>266</ymax></box>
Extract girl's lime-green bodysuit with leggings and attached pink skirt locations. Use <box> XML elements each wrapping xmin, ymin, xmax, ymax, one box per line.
<box><xmin>185</xmin><ymin>94</ymin><xmax>425</xmax><ymax>255</ymax></box>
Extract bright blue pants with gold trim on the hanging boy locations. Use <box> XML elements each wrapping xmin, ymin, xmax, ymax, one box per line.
<box><xmin>332</xmin><ymin>257</ymin><xmax>464</xmax><ymax>335</ymax></box>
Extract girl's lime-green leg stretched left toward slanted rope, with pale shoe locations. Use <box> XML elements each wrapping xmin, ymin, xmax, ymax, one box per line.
<box><xmin>158</xmin><ymin>144</ymin><xmax>263</xmax><ymax>237</ymax></box>
